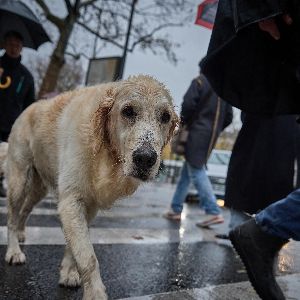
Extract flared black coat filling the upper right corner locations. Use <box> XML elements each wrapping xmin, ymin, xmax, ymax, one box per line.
<box><xmin>201</xmin><ymin>0</ymin><xmax>300</xmax><ymax>114</ymax></box>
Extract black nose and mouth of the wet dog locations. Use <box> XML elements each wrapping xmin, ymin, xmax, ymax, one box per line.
<box><xmin>132</xmin><ymin>143</ymin><xmax>157</xmax><ymax>180</ymax></box>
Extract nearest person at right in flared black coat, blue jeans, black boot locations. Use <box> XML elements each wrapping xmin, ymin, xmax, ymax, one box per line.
<box><xmin>202</xmin><ymin>0</ymin><xmax>300</xmax><ymax>300</ymax></box>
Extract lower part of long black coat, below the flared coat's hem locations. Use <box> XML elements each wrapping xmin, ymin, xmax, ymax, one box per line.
<box><xmin>225</xmin><ymin>114</ymin><xmax>300</xmax><ymax>214</ymax></box>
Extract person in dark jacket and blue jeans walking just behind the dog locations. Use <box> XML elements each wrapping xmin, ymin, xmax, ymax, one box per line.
<box><xmin>165</xmin><ymin>74</ymin><xmax>232</xmax><ymax>226</ymax></box>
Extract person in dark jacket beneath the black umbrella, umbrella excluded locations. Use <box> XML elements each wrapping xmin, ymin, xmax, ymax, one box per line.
<box><xmin>0</xmin><ymin>31</ymin><xmax>35</xmax><ymax>197</ymax></box>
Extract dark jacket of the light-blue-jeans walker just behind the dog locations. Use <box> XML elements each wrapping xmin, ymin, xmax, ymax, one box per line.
<box><xmin>181</xmin><ymin>75</ymin><xmax>232</xmax><ymax>168</ymax></box>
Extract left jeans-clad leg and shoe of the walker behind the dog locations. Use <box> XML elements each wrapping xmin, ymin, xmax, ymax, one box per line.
<box><xmin>165</xmin><ymin>162</ymin><xmax>190</xmax><ymax>220</ymax></box>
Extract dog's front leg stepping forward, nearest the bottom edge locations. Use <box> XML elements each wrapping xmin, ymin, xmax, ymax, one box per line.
<box><xmin>58</xmin><ymin>196</ymin><xmax>107</xmax><ymax>300</ymax></box>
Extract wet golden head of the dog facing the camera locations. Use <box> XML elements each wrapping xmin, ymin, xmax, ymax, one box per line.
<box><xmin>93</xmin><ymin>75</ymin><xmax>178</xmax><ymax>181</ymax></box>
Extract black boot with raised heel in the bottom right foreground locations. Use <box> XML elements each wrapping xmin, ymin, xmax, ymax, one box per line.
<box><xmin>229</xmin><ymin>219</ymin><xmax>288</xmax><ymax>300</ymax></box>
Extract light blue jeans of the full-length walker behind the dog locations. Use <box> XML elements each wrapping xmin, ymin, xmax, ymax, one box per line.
<box><xmin>171</xmin><ymin>162</ymin><xmax>221</xmax><ymax>215</ymax></box>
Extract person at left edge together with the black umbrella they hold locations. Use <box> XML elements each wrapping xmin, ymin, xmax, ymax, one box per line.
<box><xmin>0</xmin><ymin>0</ymin><xmax>50</xmax><ymax>197</ymax></box>
